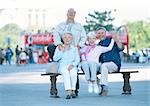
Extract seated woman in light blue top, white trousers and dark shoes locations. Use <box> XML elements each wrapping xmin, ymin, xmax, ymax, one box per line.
<box><xmin>53</xmin><ymin>33</ymin><xmax>80</xmax><ymax>99</ymax></box>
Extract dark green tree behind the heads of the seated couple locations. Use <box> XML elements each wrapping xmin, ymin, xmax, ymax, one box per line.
<box><xmin>84</xmin><ymin>11</ymin><xmax>115</xmax><ymax>32</ymax></box>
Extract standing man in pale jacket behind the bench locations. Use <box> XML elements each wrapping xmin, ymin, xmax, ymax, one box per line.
<box><xmin>53</xmin><ymin>8</ymin><xmax>86</xmax><ymax>48</ymax></box>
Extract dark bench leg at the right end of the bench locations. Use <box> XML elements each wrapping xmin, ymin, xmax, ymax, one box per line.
<box><xmin>122</xmin><ymin>73</ymin><xmax>131</xmax><ymax>95</ymax></box>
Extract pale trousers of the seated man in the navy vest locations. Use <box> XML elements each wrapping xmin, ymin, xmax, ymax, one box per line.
<box><xmin>100</xmin><ymin>62</ymin><xmax>118</xmax><ymax>86</ymax></box>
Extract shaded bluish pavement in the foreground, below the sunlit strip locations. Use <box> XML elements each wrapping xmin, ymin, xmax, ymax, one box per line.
<box><xmin>0</xmin><ymin>81</ymin><xmax>150</xmax><ymax>106</ymax></box>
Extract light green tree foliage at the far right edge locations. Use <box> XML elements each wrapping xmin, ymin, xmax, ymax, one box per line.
<box><xmin>127</xmin><ymin>21</ymin><xmax>150</xmax><ymax>50</ymax></box>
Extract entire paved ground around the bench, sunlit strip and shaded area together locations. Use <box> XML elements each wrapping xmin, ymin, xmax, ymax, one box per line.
<box><xmin>0</xmin><ymin>64</ymin><xmax>150</xmax><ymax>106</ymax></box>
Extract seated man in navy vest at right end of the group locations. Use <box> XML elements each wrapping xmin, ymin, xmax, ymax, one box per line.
<box><xmin>97</xmin><ymin>27</ymin><xmax>124</xmax><ymax>96</ymax></box>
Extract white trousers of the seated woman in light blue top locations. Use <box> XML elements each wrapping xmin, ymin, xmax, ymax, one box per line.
<box><xmin>61</xmin><ymin>67</ymin><xmax>77</xmax><ymax>90</ymax></box>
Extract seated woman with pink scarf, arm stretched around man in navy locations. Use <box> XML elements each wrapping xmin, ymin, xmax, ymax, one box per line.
<box><xmin>80</xmin><ymin>32</ymin><xmax>114</xmax><ymax>93</ymax></box>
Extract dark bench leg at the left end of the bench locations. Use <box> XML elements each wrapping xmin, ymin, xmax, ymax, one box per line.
<box><xmin>50</xmin><ymin>76</ymin><xmax>59</xmax><ymax>98</ymax></box>
